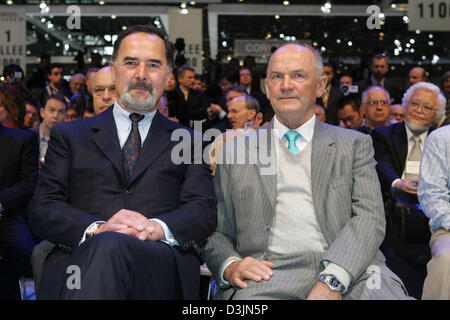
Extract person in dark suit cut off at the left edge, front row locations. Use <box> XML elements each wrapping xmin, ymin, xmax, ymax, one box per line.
<box><xmin>0</xmin><ymin>124</ymin><xmax>38</xmax><ymax>300</ymax></box>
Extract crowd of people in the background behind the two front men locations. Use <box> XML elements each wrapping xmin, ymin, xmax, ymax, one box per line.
<box><xmin>0</xmin><ymin>40</ymin><xmax>450</xmax><ymax>298</ymax></box>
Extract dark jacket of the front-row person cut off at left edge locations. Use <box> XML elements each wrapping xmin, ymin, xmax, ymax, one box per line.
<box><xmin>0</xmin><ymin>124</ymin><xmax>39</xmax><ymax>216</ymax></box>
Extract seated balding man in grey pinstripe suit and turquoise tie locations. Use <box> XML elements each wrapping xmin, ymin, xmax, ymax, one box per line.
<box><xmin>202</xmin><ymin>44</ymin><xmax>414</xmax><ymax>300</ymax></box>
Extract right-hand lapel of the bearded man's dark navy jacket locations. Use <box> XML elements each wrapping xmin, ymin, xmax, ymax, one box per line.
<box><xmin>128</xmin><ymin>111</ymin><xmax>176</xmax><ymax>185</ymax></box>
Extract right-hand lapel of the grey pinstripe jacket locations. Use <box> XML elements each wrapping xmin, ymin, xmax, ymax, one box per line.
<box><xmin>311</xmin><ymin>119</ymin><xmax>336</xmax><ymax>243</ymax></box>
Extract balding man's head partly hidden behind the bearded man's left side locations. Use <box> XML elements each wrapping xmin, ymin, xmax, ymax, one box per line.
<box><xmin>92</xmin><ymin>66</ymin><xmax>116</xmax><ymax>114</ymax></box>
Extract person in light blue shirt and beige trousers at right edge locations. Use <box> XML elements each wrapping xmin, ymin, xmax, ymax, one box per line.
<box><xmin>418</xmin><ymin>126</ymin><xmax>450</xmax><ymax>300</ymax></box>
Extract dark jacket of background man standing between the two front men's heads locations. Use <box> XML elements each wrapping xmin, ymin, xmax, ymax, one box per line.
<box><xmin>169</xmin><ymin>87</ymin><xmax>212</xmax><ymax>127</ymax></box>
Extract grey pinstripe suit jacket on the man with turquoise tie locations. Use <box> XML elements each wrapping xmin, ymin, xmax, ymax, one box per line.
<box><xmin>202</xmin><ymin>119</ymin><xmax>412</xmax><ymax>299</ymax></box>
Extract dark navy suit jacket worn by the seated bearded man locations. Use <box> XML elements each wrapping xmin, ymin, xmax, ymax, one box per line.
<box><xmin>30</xmin><ymin>108</ymin><xmax>217</xmax><ymax>299</ymax></box>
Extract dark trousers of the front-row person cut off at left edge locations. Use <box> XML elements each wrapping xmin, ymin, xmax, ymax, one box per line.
<box><xmin>0</xmin><ymin>214</ymin><xmax>34</xmax><ymax>300</ymax></box>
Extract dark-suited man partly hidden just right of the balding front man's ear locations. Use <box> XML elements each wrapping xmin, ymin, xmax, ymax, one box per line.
<box><xmin>316</xmin><ymin>62</ymin><xmax>343</xmax><ymax>125</ymax></box>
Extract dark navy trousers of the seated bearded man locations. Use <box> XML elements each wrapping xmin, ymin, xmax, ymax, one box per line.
<box><xmin>37</xmin><ymin>232</ymin><xmax>182</xmax><ymax>300</ymax></box>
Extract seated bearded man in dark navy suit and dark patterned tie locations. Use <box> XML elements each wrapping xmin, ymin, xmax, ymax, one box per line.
<box><xmin>30</xmin><ymin>26</ymin><xmax>216</xmax><ymax>299</ymax></box>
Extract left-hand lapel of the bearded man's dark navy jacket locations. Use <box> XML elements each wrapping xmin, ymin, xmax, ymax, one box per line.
<box><xmin>92</xmin><ymin>107</ymin><xmax>126</xmax><ymax>182</ymax></box>
